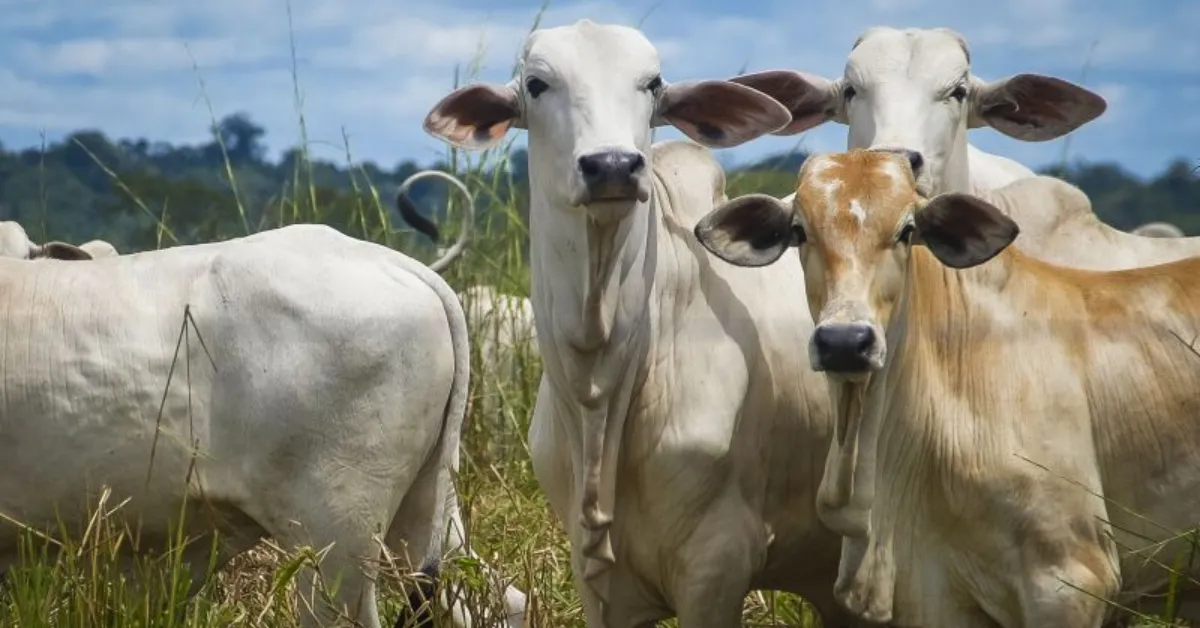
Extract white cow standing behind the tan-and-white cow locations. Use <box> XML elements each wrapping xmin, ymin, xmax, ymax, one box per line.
<box><xmin>731</xmin><ymin>28</ymin><xmax>1200</xmax><ymax>270</ymax></box>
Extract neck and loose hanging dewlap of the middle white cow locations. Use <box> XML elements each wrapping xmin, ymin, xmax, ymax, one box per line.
<box><xmin>529</xmin><ymin>146</ymin><xmax>660</xmax><ymax>602</ymax></box>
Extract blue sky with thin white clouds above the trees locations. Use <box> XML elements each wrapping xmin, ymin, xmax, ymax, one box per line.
<box><xmin>0</xmin><ymin>0</ymin><xmax>1200</xmax><ymax>180</ymax></box>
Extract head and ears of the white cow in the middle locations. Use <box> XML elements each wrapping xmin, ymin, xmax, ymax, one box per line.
<box><xmin>425</xmin><ymin>19</ymin><xmax>791</xmax><ymax>217</ymax></box>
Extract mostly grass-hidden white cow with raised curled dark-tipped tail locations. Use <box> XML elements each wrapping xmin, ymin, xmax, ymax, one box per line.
<box><xmin>396</xmin><ymin>171</ymin><xmax>538</xmax><ymax>458</ymax></box>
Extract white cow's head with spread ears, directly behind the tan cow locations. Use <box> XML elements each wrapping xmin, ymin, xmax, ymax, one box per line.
<box><xmin>733</xmin><ymin>28</ymin><xmax>1106</xmax><ymax>195</ymax></box>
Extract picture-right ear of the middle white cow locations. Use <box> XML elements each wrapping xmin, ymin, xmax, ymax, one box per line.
<box><xmin>654</xmin><ymin>80</ymin><xmax>792</xmax><ymax>148</ymax></box>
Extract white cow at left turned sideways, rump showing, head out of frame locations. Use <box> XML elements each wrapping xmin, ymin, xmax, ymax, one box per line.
<box><xmin>0</xmin><ymin>226</ymin><xmax>523</xmax><ymax>628</ymax></box>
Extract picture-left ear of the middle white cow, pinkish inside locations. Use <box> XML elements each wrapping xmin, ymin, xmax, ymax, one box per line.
<box><xmin>424</xmin><ymin>82</ymin><xmax>524</xmax><ymax>150</ymax></box>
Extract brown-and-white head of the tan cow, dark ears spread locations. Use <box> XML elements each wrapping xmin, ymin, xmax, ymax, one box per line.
<box><xmin>696</xmin><ymin>150</ymin><xmax>1019</xmax><ymax>381</ymax></box>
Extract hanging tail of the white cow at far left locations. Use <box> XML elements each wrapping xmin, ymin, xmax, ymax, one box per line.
<box><xmin>412</xmin><ymin>262</ymin><xmax>526</xmax><ymax>628</ymax></box>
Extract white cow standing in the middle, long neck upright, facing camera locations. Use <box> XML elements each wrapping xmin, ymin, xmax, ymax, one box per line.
<box><xmin>425</xmin><ymin>20</ymin><xmax>864</xmax><ymax>628</ymax></box>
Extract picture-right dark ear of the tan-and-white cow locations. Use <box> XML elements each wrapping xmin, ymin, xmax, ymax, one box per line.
<box><xmin>912</xmin><ymin>192</ymin><xmax>1021</xmax><ymax>268</ymax></box>
